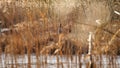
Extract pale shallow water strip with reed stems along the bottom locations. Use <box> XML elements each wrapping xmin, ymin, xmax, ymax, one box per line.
<box><xmin>0</xmin><ymin>54</ymin><xmax>120</xmax><ymax>68</ymax></box>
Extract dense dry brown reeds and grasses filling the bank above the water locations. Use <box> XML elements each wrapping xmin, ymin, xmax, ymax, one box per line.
<box><xmin>0</xmin><ymin>0</ymin><xmax>119</xmax><ymax>54</ymax></box>
